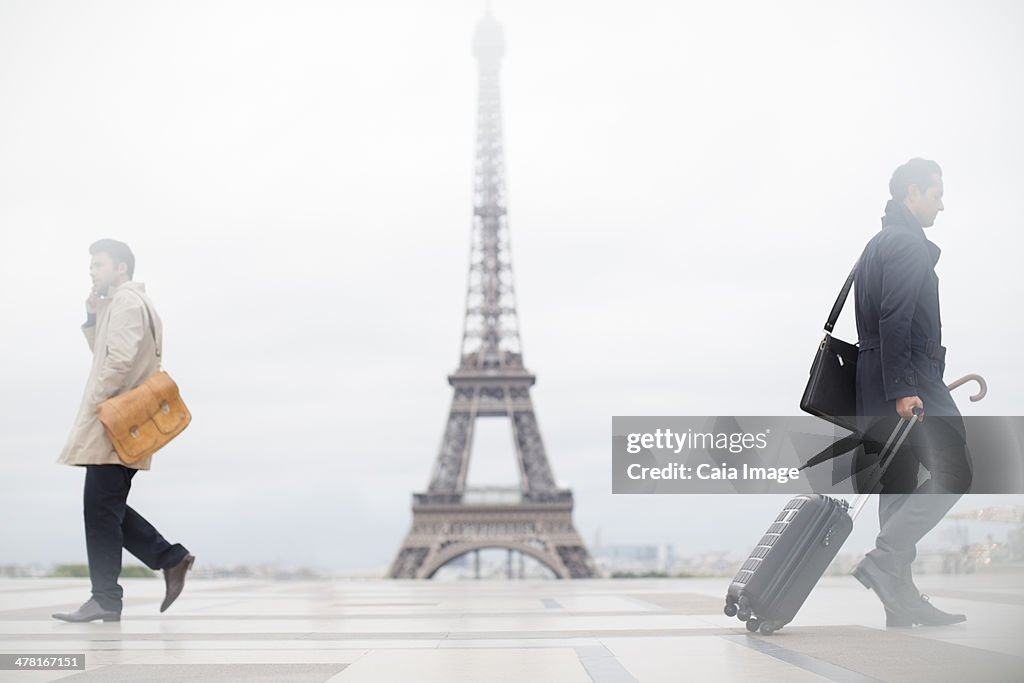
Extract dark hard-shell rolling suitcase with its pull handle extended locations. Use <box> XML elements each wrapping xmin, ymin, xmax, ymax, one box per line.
<box><xmin>724</xmin><ymin>414</ymin><xmax>921</xmax><ymax>635</ymax></box>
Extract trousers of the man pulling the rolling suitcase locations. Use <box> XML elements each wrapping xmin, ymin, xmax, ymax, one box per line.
<box><xmin>867</xmin><ymin>443</ymin><xmax>972</xmax><ymax>587</ymax></box>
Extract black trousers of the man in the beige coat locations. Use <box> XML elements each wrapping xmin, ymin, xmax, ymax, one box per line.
<box><xmin>83</xmin><ymin>465</ymin><xmax>188</xmax><ymax>611</ymax></box>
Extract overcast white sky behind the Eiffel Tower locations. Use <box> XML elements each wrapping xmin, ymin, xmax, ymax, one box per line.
<box><xmin>0</xmin><ymin>0</ymin><xmax>1024</xmax><ymax>569</ymax></box>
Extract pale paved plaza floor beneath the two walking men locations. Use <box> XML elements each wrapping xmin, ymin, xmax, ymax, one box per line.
<box><xmin>0</xmin><ymin>573</ymin><xmax>1024</xmax><ymax>683</ymax></box>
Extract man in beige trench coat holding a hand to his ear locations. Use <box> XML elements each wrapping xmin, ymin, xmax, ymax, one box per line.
<box><xmin>53</xmin><ymin>240</ymin><xmax>196</xmax><ymax>622</ymax></box>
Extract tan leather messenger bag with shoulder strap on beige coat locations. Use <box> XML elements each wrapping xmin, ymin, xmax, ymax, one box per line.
<box><xmin>97</xmin><ymin>295</ymin><xmax>191</xmax><ymax>465</ymax></box>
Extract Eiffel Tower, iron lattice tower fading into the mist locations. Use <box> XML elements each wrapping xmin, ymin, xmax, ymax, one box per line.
<box><xmin>389</xmin><ymin>7</ymin><xmax>595</xmax><ymax>579</ymax></box>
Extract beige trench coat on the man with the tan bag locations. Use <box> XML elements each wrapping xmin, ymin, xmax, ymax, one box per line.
<box><xmin>57</xmin><ymin>281</ymin><xmax>163</xmax><ymax>470</ymax></box>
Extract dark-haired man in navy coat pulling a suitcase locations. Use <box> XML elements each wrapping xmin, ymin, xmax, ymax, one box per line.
<box><xmin>854</xmin><ymin>159</ymin><xmax>971</xmax><ymax>627</ymax></box>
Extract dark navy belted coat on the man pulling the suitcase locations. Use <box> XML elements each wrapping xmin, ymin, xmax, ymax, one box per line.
<box><xmin>854</xmin><ymin>201</ymin><xmax>964</xmax><ymax>444</ymax></box>
